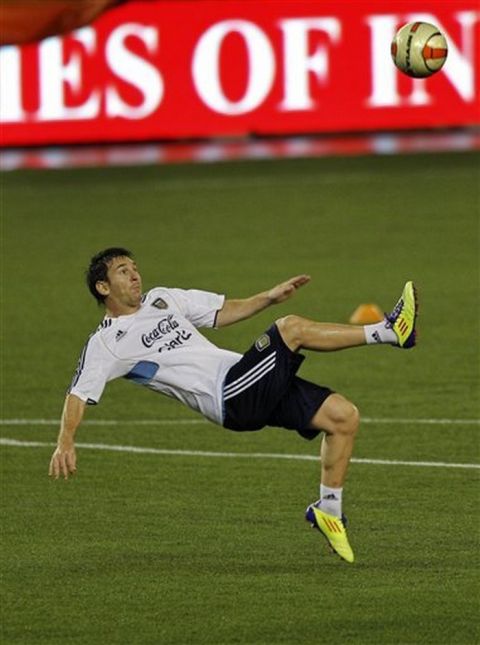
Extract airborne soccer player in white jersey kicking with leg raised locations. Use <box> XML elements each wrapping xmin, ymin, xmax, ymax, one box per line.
<box><xmin>49</xmin><ymin>248</ymin><xmax>417</xmax><ymax>562</ymax></box>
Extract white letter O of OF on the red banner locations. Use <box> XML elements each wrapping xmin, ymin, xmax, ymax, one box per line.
<box><xmin>192</xmin><ymin>20</ymin><xmax>275</xmax><ymax>115</ymax></box>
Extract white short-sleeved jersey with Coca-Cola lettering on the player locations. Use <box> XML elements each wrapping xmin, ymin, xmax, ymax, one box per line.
<box><xmin>69</xmin><ymin>287</ymin><xmax>241</xmax><ymax>424</ymax></box>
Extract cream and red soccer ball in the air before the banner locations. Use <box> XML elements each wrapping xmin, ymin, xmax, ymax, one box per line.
<box><xmin>390</xmin><ymin>22</ymin><xmax>448</xmax><ymax>78</ymax></box>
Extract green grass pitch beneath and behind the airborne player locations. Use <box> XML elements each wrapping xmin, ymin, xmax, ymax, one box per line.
<box><xmin>0</xmin><ymin>153</ymin><xmax>480</xmax><ymax>645</ymax></box>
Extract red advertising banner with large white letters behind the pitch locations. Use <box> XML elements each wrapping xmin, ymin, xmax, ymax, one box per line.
<box><xmin>0</xmin><ymin>0</ymin><xmax>480</xmax><ymax>146</ymax></box>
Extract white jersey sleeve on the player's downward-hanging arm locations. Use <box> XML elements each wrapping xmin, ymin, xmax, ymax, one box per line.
<box><xmin>68</xmin><ymin>334</ymin><xmax>108</xmax><ymax>405</ymax></box>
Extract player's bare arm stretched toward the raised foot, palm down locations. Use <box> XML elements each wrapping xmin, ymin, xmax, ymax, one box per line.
<box><xmin>216</xmin><ymin>275</ymin><xmax>310</xmax><ymax>327</ymax></box>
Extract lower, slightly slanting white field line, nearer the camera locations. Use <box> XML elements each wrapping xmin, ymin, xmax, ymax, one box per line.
<box><xmin>0</xmin><ymin>438</ymin><xmax>480</xmax><ymax>469</ymax></box>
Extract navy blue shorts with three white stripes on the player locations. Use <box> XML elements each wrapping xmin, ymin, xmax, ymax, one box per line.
<box><xmin>223</xmin><ymin>325</ymin><xmax>332</xmax><ymax>439</ymax></box>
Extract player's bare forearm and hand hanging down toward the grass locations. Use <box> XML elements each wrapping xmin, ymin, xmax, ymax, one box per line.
<box><xmin>48</xmin><ymin>394</ymin><xmax>86</xmax><ymax>479</ymax></box>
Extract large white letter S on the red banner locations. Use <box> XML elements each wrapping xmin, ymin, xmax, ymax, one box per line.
<box><xmin>105</xmin><ymin>23</ymin><xmax>164</xmax><ymax>119</ymax></box>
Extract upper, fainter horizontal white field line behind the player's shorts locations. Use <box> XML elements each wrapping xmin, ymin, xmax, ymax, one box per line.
<box><xmin>0</xmin><ymin>417</ymin><xmax>480</xmax><ymax>426</ymax></box>
